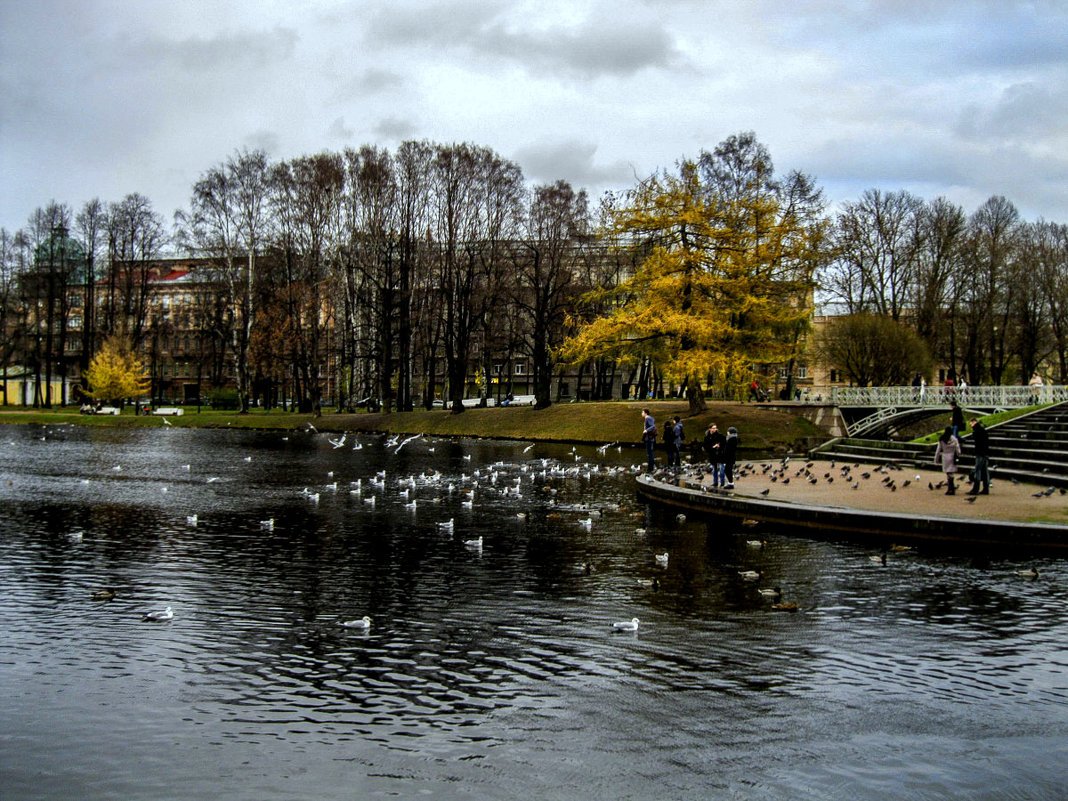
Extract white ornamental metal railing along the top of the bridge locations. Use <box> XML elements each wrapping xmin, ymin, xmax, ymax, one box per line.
<box><xmin>831</xmin><ymin>384</ymin><xmax>1068</xmax><ymax>409</ymax></box>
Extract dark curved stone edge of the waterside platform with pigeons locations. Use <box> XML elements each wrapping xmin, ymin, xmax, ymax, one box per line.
<box><xmin>637</xmin><ymin>474</ymin><xmax>1068</xmax><ymax>555</ymax></box>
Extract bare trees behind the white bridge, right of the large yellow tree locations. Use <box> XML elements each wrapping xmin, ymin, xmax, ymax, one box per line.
<box><xmin>821</xmin><ymin>189</ymin><xmax>1068</xmax><ymax>384</ymax></box>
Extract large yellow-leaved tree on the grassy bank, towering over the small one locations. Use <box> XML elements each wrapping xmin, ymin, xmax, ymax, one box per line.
<box><xmin>557</xmin><ymin>134</ymin><xmax>827</xmax><ymax>411</ymax></box>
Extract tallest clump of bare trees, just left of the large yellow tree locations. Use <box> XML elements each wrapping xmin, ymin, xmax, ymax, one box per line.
<box><xmin>176</xmin><ymin>141</ymin><xmax>598</xmax><ymax>411</ymax></box>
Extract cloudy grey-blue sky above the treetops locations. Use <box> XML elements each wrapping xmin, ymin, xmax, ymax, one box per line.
<box><xmin>0</xmin><ymin>0</ymin><xmax>1068</xmax><ymax>237</ymax></box>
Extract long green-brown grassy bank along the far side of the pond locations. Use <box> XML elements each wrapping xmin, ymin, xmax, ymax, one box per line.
<box><xmin>0</xmin><ymin>401</ymin><xmax>828</xmax><ymax>454</ymax></box>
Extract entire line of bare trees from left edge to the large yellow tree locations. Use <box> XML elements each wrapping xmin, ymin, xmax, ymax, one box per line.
<box><xmin>0</xmin><ymin>141</ymin><xmax>606</xmax><ymax>411</ymax></box>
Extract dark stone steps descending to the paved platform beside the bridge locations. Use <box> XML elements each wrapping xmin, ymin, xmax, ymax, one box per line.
<box><xmin>808</xmin><ymin>403</ymin><xmax>1068</xmax><ymax>487</ymax></box>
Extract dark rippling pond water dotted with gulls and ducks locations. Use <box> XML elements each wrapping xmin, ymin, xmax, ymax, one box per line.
<box><xmin>0</xmin><ymin>426</ymin><xmax>1068</xmax><ymax>800</ymax></box>
